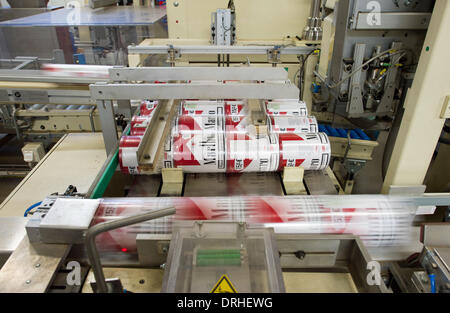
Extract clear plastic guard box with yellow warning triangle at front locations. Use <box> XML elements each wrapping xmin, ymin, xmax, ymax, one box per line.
<box><xmin>161</xmin><ymin>221</ymin><xmax>284</xmax><ymax>293</ymax></box>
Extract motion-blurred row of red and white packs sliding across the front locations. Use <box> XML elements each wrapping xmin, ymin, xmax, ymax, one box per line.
<box><xmin>93</xmin><ymin>195</ymin><xmax>417</xmax><ymax>251</ymax></box>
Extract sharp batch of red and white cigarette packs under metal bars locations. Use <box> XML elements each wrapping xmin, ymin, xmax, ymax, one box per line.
<box><xmin>119</xmin><ymin>100</ymin><xmax>331</xmax><ymax>174</ymax></box>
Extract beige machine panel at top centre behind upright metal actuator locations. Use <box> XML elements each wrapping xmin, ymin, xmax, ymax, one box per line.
<box><xmin>167</xmin><ymin>0</ymin><xmax>311</xmax><ymax>40</ymax></box>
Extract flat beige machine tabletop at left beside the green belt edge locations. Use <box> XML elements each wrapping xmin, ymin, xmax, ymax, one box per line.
<box><xmin>0</xmin><ymin>133</ymin><xmax>106</xmax><ymax>217</ymax></box>
